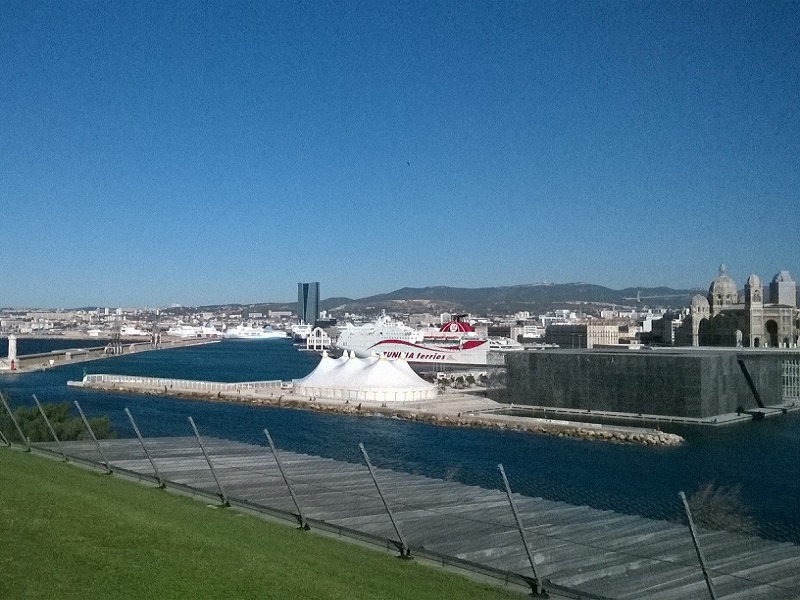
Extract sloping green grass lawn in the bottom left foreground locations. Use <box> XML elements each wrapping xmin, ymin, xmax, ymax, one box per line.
<box><xmin>0</xmin><ymin>448</ymin><xmax>519</xmax><ymax>599</ymax></box>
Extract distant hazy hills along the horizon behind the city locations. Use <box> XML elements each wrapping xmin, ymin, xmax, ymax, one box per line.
<box><xmin>180</xmin><ymin>283</ymin><xmax>705</xmax><ymax>317</ymax></box>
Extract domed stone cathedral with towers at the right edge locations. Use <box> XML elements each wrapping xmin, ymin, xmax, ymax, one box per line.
<box><xmin>675</xmin><ymin>265</ymin><xmax>800</xmax><ymax>348</ymax></box>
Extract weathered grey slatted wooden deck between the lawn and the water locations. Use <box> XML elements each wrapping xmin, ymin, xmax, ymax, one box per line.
<box><xmin>31</xmin><ymin>437</ymin><xmax>800</xmax><ymax>600</ymax></box>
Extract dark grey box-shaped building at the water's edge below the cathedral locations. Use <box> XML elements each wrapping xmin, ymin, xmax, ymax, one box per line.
<box><xmin>504</xmin><ymin>350</ymin><xmax>789</xmax><ymax>418</ymax></box>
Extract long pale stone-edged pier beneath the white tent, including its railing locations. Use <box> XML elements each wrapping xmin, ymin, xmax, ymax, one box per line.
<box><xmin>68</xmin><ymin>374</ymin><xmax>684</xmax><ymax>446</ymax></box>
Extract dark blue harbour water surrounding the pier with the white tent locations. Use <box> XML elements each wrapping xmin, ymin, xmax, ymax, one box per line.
<box><xmin>0</xmin><ymin>340</ymin><xmax>800</xmax><ymax>543</ymax></box>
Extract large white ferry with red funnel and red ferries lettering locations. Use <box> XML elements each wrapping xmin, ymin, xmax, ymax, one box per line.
<box><xmin>335</xmin><ymin>314</ymin><xmax>522</xmax><ymax>365</ymax></box>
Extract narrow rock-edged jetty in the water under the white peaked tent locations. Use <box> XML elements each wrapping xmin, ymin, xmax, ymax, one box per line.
<box><xmin>75</xmin><ymin>381</ymin><xmax>684</xmax><ymax>447</ymax></box>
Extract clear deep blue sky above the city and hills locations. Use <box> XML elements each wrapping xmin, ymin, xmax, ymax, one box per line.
<box><xmin>0</xmin><ymin>0</ymin><xmax>800</xmax><ymax>307</ymax></box>
